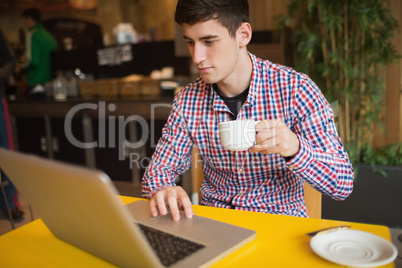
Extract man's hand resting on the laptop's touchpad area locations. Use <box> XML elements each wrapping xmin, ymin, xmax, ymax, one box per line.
<box><xmin>149</xmin><ymin>186</ymin><xmax>194</xmax><ymax>221</ymax></box>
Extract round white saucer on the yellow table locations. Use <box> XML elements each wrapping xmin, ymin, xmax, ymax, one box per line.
<box><xmin>310</xmin><ymin>230</ymin><xmax>398</xmax><ymax>267</ymax></box>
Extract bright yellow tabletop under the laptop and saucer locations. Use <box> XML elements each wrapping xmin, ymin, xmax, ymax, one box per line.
<box><xmin>0</xmin><ymin>197</ymin><xmax>394</xmax><ymax>268</ymax></box>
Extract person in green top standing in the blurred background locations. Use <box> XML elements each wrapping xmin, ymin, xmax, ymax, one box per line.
<box><xmin>21</xmin><ymin>8</ymin><xmax>57</xmax><ymax>97</ymax></box>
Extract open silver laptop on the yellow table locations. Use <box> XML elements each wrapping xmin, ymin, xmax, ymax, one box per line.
<box><xmin>0</xmin><ymin>149</ymin><xmax>256</xmax><ymax>268</ymax></box>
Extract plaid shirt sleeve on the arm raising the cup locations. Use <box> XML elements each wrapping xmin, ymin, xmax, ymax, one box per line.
<box><xmin>286</xmin><ymin>78</ymin><xmax>354</xmax><ymax>200</ymax></box>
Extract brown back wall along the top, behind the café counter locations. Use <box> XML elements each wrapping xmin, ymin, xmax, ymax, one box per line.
<box><xmin>0</xmin><ymin>0</ymin><xmax>286</xmax><ymax>42</ymax></box>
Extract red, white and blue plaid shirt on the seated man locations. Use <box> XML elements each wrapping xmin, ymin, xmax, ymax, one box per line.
<box><xmin>142</xmin><ymin>54</ymin><xmax>353</xmax><ymax>217</ymax></box>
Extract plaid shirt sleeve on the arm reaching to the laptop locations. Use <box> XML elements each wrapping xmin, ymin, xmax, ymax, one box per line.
<box><xmin>142</xmin><ymin>94</ymin><xmax>193</xmax><ymax>199</ymax></box>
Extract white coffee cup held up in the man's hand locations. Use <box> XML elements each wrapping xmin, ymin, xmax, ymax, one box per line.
<box><xmin>218</xmin><ymin>119</ymin><xmax>259</xmax><ymax>152</ymax></box>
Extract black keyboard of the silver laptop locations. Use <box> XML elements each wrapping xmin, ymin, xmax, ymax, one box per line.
<box><xmin>138</xmin><ymin>224</ymin><xmax>205</xmax><ymax>266</ymax></box>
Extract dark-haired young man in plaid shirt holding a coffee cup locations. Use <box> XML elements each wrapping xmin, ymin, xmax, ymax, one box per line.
<box><xmin>143</xmin><ymin>0</ymin><xmax>353</xmax><ymax>220</ymax></box>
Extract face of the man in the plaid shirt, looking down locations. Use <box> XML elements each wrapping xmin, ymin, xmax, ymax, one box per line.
<box><xmin>182</xmin><ymin>19</ymin><xmax>239</xmax><ymax>84</ymax></box>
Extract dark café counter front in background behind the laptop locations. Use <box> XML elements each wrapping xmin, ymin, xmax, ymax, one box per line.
<box><xmin>8</xmin><ymin>95</ymin><xmax>173</xmax><ymax>184</ymax></box>
